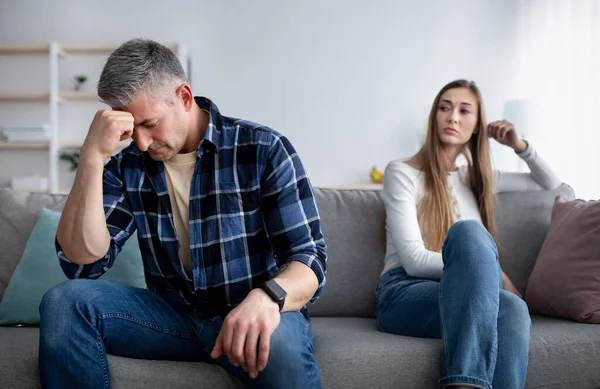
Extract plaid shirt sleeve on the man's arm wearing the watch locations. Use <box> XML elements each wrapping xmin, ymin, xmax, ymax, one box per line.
<box><xmin>262</xmin><ymin>136</ymin><xmax>327</xmax><ymax>302</ymax></box>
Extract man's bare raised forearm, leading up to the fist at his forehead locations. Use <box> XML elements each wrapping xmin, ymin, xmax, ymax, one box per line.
<box><xmin>56</xmin><ymin>160</ymin><xmax>110</xmax><ymax>265</ymax></box>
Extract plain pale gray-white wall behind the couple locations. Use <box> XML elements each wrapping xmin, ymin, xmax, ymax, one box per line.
<box><xmin>5</xmin><ymin>0</ymin><xmax>577</xmax><ymax>194</ymax></box>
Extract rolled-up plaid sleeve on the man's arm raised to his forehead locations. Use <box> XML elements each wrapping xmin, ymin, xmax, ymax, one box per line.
<box><xmin>55</xmin><ymin>157</ymin><xmax>135</xmax><ymax>279</ymax></box>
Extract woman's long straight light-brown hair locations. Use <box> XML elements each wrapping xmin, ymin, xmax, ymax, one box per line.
<box><xmin>417</xmin><ymin>80</ymin><xmax>495</xmax><ymax>252</ymax></box>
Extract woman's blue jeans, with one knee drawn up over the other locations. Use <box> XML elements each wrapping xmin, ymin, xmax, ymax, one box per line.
<box><xmin>377</xmin><ymin>220</ymin><xmax>531</xmax><ymax>389</ymax></box>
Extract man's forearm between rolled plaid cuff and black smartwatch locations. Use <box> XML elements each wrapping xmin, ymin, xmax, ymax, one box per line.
<box><xmin>274</xmin><ymin>261</ymin><xmax>319</xmax><ymax>312</ymax></box>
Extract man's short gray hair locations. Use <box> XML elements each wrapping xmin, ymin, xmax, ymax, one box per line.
<box><xmin>98</xmin><ymin>39</ymin><xmax>188</xmax><ymax>108</ymax></box>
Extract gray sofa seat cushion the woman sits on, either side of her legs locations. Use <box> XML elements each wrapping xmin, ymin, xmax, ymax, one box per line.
<box><xmin>312</xmin><ymin>316</ymin><xmax>600</xmax><ymax>389</ymax></box>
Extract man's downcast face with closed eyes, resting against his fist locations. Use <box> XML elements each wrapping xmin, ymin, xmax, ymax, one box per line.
<box><xmin>122</xmin><ymin>91</ymin><xmax>187</xmax><ymax>161</ymax></box>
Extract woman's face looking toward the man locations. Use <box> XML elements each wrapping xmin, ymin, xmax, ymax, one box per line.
<box><xmin>436</xmin><ymin>88</ymin><xmax>478</xmax><ymax>146</ymax></box>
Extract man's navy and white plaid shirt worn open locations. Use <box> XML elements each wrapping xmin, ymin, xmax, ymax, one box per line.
<box><xmin>56</xmin><ymin>97</ymin><xmax>327</xmax><ymax>314</ymax></box>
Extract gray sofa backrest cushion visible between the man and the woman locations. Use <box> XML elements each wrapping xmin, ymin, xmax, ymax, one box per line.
<box><xmin>308</xmin><ymin>188</ymin><xmax>385</xmax><ymax>317</ymax></box>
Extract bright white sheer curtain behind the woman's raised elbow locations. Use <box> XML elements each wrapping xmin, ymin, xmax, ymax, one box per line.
<box><xmin>515</xmin><ymin>0</ymin><xmax>600</xmax><ymax>199</ymax></box>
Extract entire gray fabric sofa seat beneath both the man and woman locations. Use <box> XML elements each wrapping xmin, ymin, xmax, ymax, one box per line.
<box><xmin>0</xmin><ymin>316</ymin><xmax>600</xmax><ymax>389</ymax></box>
